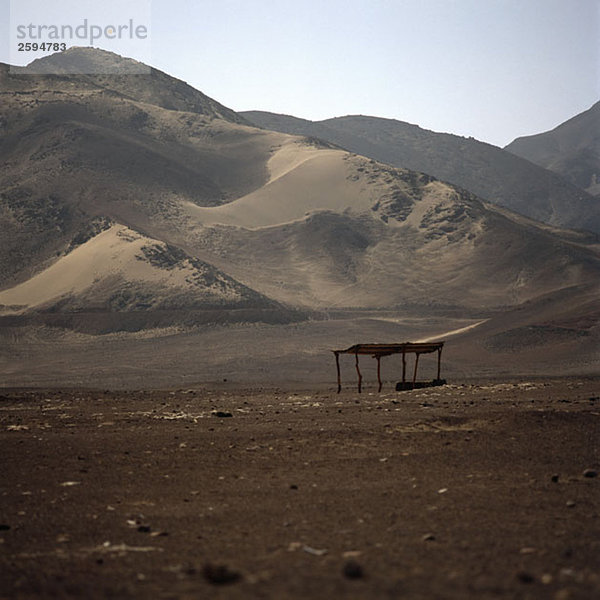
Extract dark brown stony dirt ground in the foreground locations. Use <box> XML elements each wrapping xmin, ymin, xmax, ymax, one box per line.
<box><xmin>0</xmin><ymin>378</ymin><xmax>600</xmax><ymax>600</ymax></box>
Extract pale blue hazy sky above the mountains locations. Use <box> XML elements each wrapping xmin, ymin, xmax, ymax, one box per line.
<box><xmin>0</xmin><ymin>0</ymin><xmax>600</xmax><ymax>146</ymax></box>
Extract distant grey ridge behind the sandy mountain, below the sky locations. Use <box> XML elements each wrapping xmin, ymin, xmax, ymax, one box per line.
<box><xmin>242</xmin><ymin>111</ymin><xmax>600</xmax><ymax>232</ymax></box>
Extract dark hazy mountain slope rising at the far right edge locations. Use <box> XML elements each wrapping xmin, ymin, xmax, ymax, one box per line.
<box><xmin>505</xmin><ymin>102</ymin><xmax>600</xmax><ymax>196</ymax></box>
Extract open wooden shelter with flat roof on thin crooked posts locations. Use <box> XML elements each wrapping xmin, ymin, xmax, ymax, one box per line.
<box><xmin>332</xmin><ymin>342</ymin><xmax>444</xmax><ymax>394</ymax></box>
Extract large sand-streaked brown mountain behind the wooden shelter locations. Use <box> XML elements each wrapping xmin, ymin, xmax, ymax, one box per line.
<box><xmin>0</xmin><ymin>49</ymin><xmax>600</xmax><ymax>376</ymax></box>
